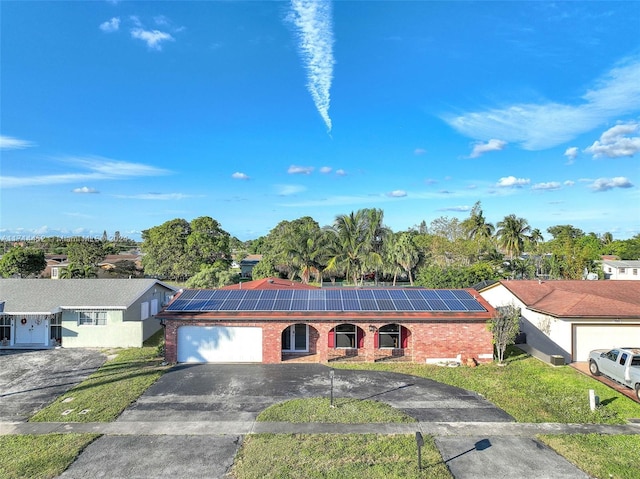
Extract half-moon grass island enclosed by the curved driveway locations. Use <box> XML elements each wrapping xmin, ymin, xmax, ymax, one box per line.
<box><xmin>257</xmin><ymin>398</ymin><xmax>415</xmax><ymax>424</ymax></box>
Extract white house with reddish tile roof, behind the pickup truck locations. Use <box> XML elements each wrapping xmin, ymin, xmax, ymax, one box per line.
<box><xmin>478</xmin><ymin>280</ymin><xmax>640</xmax><ymax>362</ymax></box>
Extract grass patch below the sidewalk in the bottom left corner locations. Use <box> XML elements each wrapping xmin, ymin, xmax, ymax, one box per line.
<box><xmin>0</xmin><ymin>434</ymin><xmax>98</xmax><ymax>479</ymax></box>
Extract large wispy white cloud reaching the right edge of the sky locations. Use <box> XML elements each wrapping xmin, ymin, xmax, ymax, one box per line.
<box><xmin>443</xmin><ymin>57</ymin><xmax>640</xmax><ymax>150</ymax></box>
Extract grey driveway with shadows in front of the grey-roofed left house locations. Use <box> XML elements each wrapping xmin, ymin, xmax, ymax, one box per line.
<box><xmin>0</xmin><ymin>348</ymin><xmax>107</xmax><ymax>421</ymax></box>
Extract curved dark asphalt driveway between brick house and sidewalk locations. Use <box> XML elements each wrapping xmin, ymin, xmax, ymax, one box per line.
<box><xmin>118</xmin><ymin>364</ymin><xmax>513</xmax><ymax>422</ymax></box>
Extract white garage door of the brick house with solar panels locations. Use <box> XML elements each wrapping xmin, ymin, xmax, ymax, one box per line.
<box><xmin>178</xmin><ymin>326</ymin><xmax>262</xmax><ymax>363</ymax></box>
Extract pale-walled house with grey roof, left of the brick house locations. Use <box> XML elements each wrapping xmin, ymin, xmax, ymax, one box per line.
<box><xmin>0</xmin><ymin>279</ymin><xmax>176</xmax><ymax>349</ymax></box>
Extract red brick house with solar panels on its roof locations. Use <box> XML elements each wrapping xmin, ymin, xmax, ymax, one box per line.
<box><xmin>158</xmin><ymin>282</ymin><xmax>495</xmax><ymax>363</ymax></box>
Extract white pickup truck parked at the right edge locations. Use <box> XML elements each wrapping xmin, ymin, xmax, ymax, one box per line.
<box><xmin>589</xmin><ymin>348</ymin><xmax>640</xmax><ymax>401</ymax></box>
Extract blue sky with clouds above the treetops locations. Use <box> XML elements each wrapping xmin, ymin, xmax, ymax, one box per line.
<box><xmin>0</xmin><ymin>0</ymin><xmax>640</xmax><ymax>244</ymax></box>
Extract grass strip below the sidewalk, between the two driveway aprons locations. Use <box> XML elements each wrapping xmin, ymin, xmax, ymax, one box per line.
<box><xmin>231</xmin><ymin>434</ymin><xmax>452</xmax><ymax>479</ymax></box>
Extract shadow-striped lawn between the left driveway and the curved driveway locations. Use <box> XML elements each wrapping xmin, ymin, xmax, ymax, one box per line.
<box><xmin>29</xmin><ymin>336</ymin><xmax>166</xmax><ymax>422</ymax></box>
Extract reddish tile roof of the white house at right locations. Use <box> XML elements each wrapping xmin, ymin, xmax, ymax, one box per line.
<box><xmin>492</xmin><ymin>280</ymin><xmax>640</xmax><ymax>318</ymax></box>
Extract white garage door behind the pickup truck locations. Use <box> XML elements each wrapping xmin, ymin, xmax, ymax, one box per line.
<box><xmin>573</xmin><ymin>324</ymin><xmax>640</xmax><ymax>361</ymax></box>
